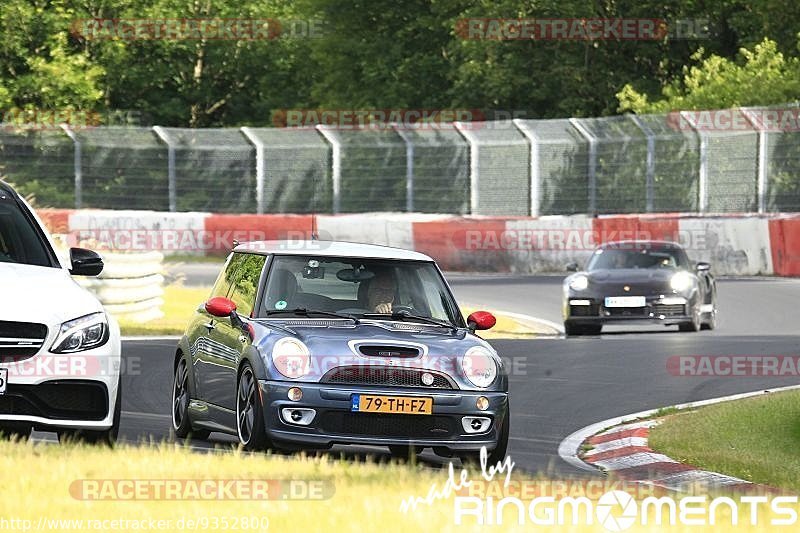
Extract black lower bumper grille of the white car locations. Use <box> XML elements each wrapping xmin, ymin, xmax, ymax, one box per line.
<box><xmin>0</xmin><ymin>380</ymin><xmax>108</xmax><ymax>420</ymax></box>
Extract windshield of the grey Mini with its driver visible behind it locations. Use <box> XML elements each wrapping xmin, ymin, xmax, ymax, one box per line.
<box><xmin>259</xmin><ymin>256</ymin><xmax>463</xmax><ymax>326</ymax></box>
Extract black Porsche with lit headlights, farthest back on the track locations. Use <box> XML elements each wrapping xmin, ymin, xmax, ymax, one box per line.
<box><xmin>563</xmin><ymin>241</ymin><xmax>717</xmax><ymax>336</ymax></box>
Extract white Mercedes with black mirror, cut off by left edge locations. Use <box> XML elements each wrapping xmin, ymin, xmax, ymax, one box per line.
<box><xmin>0</xmin><ymin>181</ymin><xmax>121</xmax><ymax>444</ymax></box>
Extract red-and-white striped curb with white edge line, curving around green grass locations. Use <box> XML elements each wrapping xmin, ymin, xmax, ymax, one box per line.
<box><xmin>558</xmin><ymin>385</ymin><xmax>800</xmax><ymax>492</ymax></box>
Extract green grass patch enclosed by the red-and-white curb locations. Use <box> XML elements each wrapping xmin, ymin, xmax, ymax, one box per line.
<box><xmin>649</xmin><ymin>391</ymin><xmax>800</xmax><ymax>492</ymax></box>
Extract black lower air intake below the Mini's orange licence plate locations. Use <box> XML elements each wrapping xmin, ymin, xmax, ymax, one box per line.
<box><xmin>320</xmin><ymin>411</ymin><xmax>456</xmax><ymax>439</ymax></box>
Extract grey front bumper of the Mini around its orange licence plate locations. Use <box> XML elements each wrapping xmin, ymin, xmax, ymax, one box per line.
<box><xmin>259</xmin><ymin>381</ymin><xmax>508</xmax><ymax>452</ymax></box>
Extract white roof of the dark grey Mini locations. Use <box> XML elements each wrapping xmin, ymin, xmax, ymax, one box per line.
<box><xmin>234</xmin><ymin>241</ymin><xmax>433</xmax><ymax>261</ymax></box>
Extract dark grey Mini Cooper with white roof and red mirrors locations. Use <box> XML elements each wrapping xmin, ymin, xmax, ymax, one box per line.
<box><xmin>172</xmin><ymin>241</ymin><xmax>510</xmax><ymax>463</ymax></box>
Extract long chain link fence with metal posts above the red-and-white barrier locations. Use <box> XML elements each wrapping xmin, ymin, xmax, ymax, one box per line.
<box><xmin>0</xmin><ymin>104</ymin><xmax>800</xmax><ymax>216</ymax></box>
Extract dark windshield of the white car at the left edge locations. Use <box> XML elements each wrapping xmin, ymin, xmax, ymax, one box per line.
<box><xmin>0</xmin><ymin>189</ymin><xmax>55</xmax><ymax>267</ymax></box>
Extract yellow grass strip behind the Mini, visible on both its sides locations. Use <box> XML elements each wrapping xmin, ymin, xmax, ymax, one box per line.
<box><xmin>120</xmin><ymin>284</ymin><xmax>548</xmax><ymax>339</ymax></box>
